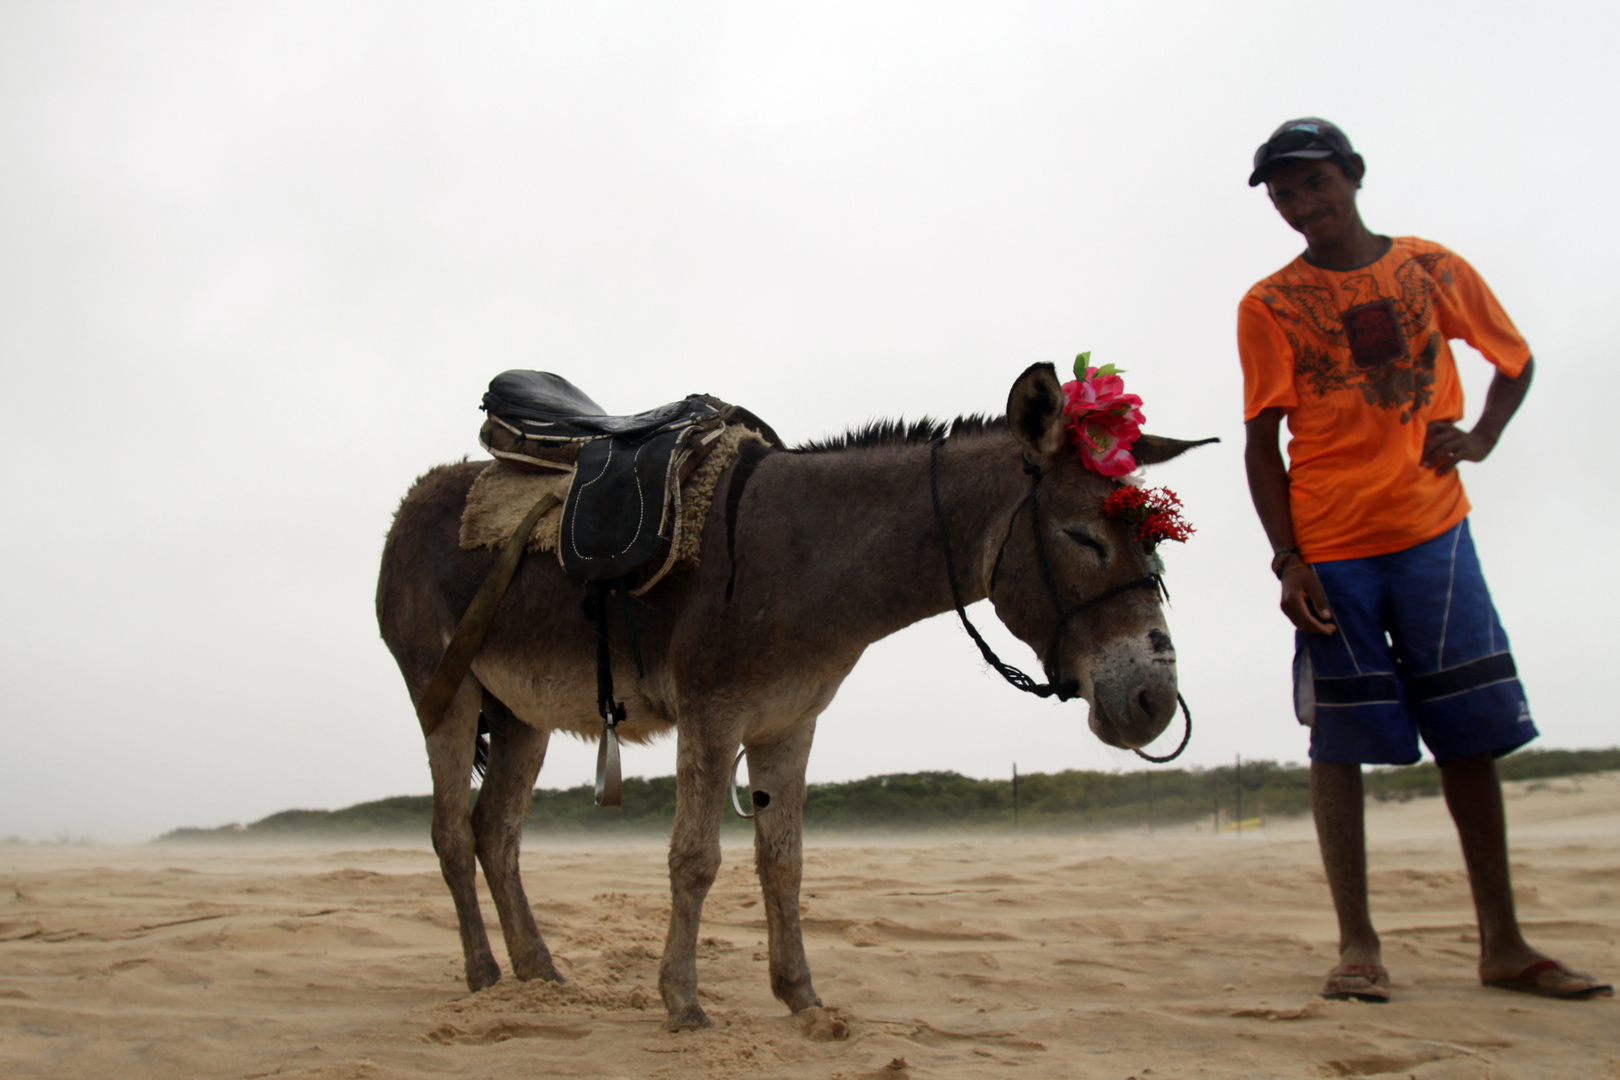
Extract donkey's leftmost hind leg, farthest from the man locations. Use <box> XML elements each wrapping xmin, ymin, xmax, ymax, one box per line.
<box><xmin>428</xmin><ymin>675</ymin><xmax>501</xmax><ymax>991</ymax></box>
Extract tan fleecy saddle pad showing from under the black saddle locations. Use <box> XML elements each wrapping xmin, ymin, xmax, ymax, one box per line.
<box><xmin>460</xmin><ymin>424</ymin><xmax>771</xmax><ymax>596</ymax></box>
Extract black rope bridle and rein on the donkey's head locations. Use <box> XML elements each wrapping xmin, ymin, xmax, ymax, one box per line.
<box><xmin>928</xmin><ymin>436</ymin><xmax>1192</xmax><ymax>764</ymax></box>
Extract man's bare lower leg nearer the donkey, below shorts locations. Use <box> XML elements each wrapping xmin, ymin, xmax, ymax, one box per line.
<box><xmin>1311</xmin><ymin>761</ymin><xmax>1383</xmax><ymax>965</ymax></box>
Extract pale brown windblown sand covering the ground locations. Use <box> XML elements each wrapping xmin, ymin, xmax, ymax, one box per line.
<box><xmin>0</xmin><ymin>774</ymin><xmax>1620</xmax><ymax>1080</ymax></box>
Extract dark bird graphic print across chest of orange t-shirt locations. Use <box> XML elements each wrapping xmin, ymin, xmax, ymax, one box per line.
<box><xmin>1264</xmin><ymin>253</ymin><xmax>1450</xmax><ymax>424</ymax></box>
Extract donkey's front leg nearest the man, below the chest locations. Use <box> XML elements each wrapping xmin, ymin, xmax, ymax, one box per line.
<box><xmin>748</xmin><ymin>719</ymin><xmax>821</xmax><ymax>1012</ymax></box>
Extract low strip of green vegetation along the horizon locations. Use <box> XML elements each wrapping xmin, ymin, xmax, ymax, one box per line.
<box><xmin>160</xmin><ymin>748</ymin><xmax>1620</xmax><ymax>842</ymax></box>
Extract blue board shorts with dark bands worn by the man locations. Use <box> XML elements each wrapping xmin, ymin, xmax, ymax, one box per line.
<box><xmin>1294</xmin><ymin>520</ymin><xmax>1536</xmax><ymax>764</ymax></box>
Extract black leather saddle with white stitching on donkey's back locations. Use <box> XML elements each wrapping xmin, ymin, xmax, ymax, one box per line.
<box><xmin>480</xmin><ymin>371</ymin><xmax>781</xmax><ymax>581</ymax></box>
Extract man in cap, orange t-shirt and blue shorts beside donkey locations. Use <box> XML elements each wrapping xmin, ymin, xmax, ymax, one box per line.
<box><xmin>1238</xmin><ymin>118</ymin><xmax>1614</xmax><ymax>1002</ymax></box>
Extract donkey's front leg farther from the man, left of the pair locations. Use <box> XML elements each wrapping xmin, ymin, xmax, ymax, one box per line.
<box><xmin>658</xmin><ymin>717</ymin><xmax>735</xmax><ymax>1031</ymax></box>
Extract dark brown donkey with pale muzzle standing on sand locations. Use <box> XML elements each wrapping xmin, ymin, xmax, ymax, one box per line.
<box><xmin>377</xmin><ymin>364</ymin><xmax>1197</xmax><ymax>1030</ymax></box>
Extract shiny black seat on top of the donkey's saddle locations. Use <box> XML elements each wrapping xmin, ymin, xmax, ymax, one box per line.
<box><xmin>484</xmin><ymin>371</ymin><xmax>719</xmax><ymax>440</ymax></box>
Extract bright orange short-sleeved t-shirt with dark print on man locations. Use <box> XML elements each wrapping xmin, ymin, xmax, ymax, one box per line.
<box><xmin>1238</xmin><ymin>236</ymin><xmax>1529</xmax><ymax>562</ymax></box>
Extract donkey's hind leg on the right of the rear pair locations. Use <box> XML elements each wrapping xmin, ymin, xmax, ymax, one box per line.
<box><xmin>473</xmin><ymin>690</ymin><xmax>564</xmax><ymax>983</ymax></box>
